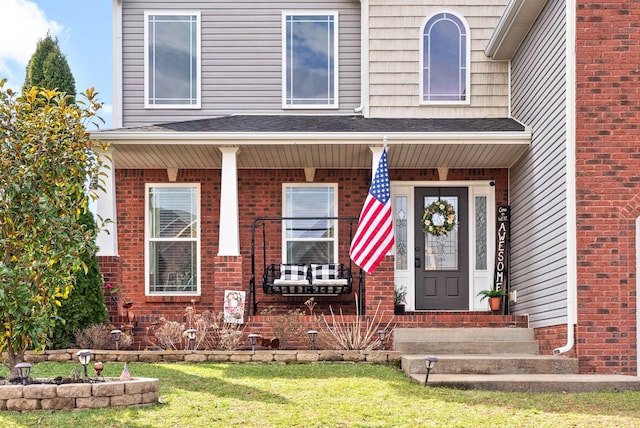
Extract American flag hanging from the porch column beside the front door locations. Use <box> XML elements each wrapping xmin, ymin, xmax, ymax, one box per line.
<box><xmin>349</xmin><ymin>147</ymin><xmax>394</xmax><ymax>273</ymax></box>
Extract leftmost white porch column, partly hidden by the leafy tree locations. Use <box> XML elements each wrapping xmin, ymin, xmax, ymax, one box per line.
<box><xmin>94</xmin><ymin>148</ymin><xmax>118</xmax><ymax>256</ymax></box>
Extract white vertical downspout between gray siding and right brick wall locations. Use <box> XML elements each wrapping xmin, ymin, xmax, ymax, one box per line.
<box><xmin>553</xmin><ymin>0</ymin><xmax>578</xmax><ymax>354</ymax></box>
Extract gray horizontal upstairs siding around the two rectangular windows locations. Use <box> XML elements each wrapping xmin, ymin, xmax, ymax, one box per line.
<box><xmin>122</xmin><ymin>0</ymin><xmax>361</xmax><ymax>126</ymax></box>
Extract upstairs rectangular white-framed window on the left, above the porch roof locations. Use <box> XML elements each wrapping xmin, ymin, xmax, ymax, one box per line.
<box><xmin>144</xmin><ymin>11</ymin><xmax>200</xmax><ymax>108</ymax></box>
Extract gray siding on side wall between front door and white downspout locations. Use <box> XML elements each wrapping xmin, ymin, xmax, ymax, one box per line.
<box><xmin>510</xmin><ymin>0</ymin><xmax>567</xmax><ymax>327</ymax></box>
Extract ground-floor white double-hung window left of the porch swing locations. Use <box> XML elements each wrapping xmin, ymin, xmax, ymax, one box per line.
<box><xmin>145</xmin><ymin>183</ymin><xmax>200</xmax><ymax>295</ymax></box>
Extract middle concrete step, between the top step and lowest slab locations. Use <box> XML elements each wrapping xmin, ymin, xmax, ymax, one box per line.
<box><xmin>401</xmin><ymin>354</ymin><xmax>578</xmax><ymax>375</ymax></box>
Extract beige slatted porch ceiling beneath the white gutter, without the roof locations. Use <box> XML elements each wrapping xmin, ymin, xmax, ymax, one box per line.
<box><xmin>113</xmin><ymin>140</ymin><xmax>528</xmax><ymax>169</ymax></box>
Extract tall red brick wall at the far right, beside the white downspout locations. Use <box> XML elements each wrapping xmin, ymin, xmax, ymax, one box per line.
<box><xmin>576</xmin><ymin>1</ymin><xmax>640</xmax><ymax>374</ymax></box>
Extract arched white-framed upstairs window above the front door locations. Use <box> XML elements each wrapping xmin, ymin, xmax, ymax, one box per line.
<box><xmin>420</xmin><ymin>12</ymin><xmax>470</xmax><ymax>104</ymax></box>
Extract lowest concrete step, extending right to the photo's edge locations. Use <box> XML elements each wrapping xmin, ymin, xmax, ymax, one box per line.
<box><xmin>410</xmin><ymin>371</ymin><xmax>640</xmax><ymax>393</ymax></box>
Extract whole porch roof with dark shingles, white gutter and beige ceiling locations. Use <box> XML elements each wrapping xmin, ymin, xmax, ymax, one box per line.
<box><xmin>94</xmin><ymin>115</ymin><xmax>531</xmax><ymax>169</ymax></box>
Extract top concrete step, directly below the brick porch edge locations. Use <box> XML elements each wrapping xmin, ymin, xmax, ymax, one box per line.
<box><xmin>393</xmin><ymin>327</ymin><xmax>539</xmax><ymax>355</ymax></box>
